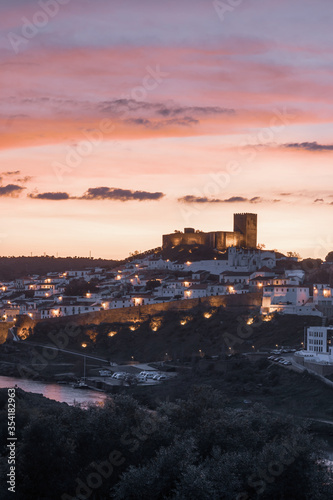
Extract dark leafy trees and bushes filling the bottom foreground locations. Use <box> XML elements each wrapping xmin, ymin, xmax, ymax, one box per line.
<box><xmin>0</xmin><ymin>386</ymin><xmax>332</xmax><ymax>500</ymax></box>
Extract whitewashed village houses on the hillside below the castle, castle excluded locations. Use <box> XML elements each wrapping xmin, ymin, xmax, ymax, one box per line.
<box><xmin>0</xmin><ymin>247</ymin><xmax>333</xmax><ymax>322</ymax></box>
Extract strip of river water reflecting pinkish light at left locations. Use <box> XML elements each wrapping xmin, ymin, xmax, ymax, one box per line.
<box><xmin>0</xmin><ymin>377</ymin><xmax>107</xmax><ymax>405</ymax></box>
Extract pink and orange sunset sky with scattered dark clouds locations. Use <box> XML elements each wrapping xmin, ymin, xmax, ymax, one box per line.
<box><xmin>0</xmin><ymin>0</ymin><xmax>333</xmax><ymax>258</ymax></box>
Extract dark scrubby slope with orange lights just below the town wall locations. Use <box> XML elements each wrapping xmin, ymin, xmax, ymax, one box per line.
<box><xmin>12</xmin><ymin>305</ymin><xmax>321</xmax><ymax>363</ymax></box>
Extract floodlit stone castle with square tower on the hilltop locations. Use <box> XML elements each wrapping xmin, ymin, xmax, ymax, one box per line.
<box><xmin>163</xmin><ymin>213</ymin><xmax>257</xmax><ymax>250</ymax></box>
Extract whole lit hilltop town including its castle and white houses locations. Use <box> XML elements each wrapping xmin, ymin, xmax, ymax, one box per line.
<box><xmin>0</xmin><ymin>214</ymin><xmax>333</xmax><ymax>371</ymax></box>
